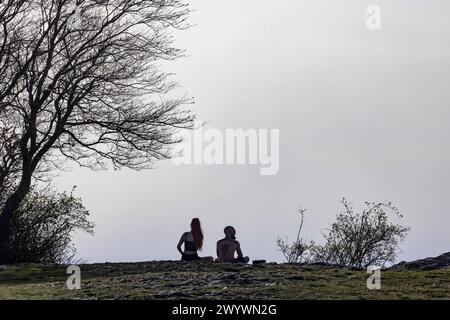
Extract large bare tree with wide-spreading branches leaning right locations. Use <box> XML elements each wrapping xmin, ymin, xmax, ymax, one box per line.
<box><xmin>0</xmin><ymin>0</ymin><xmax>194</xmax><ymax>263</ymax></box>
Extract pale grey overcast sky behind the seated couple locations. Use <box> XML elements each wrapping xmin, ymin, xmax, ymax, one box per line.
<box><xmin>55</xmin><ymin>0</ymin><xmax>450</xmax><ymax>262</ymax></box>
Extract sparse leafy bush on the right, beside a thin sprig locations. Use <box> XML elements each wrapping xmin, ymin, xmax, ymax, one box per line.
<box><xmin>313</xmin><ymin>199</ymin><xmax>409</xmax><ymax>268</ymax></box>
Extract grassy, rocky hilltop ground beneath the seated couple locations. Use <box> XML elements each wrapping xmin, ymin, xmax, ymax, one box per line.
<box><xmin>0</xmin><ymin>253</ymin><xmax>450</xmax><ymax>299</ymax></box>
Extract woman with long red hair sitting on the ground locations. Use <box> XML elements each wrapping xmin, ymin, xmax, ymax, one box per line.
<box><xmin>177</xmin><ymin>218</ymin><xmax>214</xmax><ymax>261</ymax></box>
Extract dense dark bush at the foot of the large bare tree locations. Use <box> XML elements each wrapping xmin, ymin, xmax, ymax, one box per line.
<box><xmin>9</xmin><ymin>188</ymin><xmax>94</xmax><ymax>263</ymax></box>
